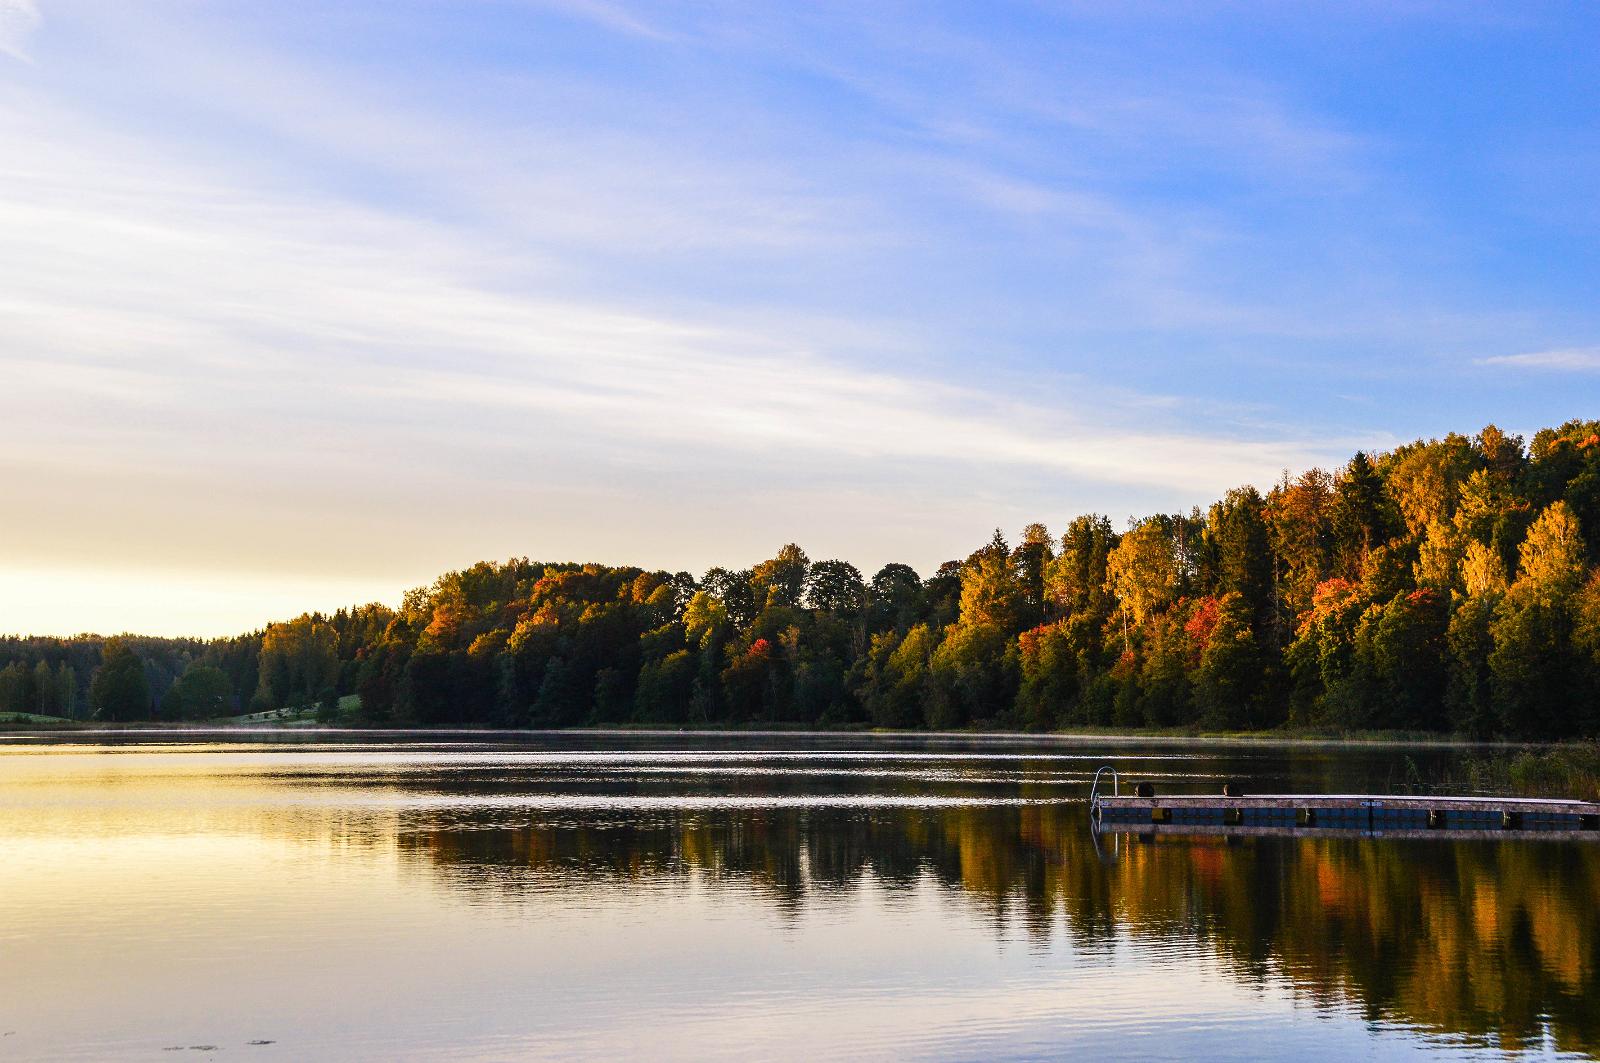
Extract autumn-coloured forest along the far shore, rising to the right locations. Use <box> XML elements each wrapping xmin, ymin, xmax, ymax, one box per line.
<box><xmin>0</xmin><ymin>421</ymin><xmax>1600</xmax><ymax>738</ymax></box>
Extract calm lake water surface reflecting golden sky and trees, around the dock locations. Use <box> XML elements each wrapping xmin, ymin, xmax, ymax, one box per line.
<box><xmin>0</xmin><ymin>735</ymin><xmax>1600</xmax><ymax>1061</ymax></box>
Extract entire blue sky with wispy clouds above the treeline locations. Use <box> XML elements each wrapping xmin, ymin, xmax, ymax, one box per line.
<box><xmin>0</xmin><ymin>0</ymin><xmax>1600</xmax><ymax>636</ymax></box>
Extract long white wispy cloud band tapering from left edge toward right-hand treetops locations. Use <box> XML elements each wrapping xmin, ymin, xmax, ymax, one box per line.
<box><xmin>0</xmin><ymin>91</ymin><xmax>1337</xmax><ymax>488</ymax></box>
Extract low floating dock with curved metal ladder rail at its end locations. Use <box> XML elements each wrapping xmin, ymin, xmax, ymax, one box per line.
<box><xmin>1090</xmin><ymin>773</ymin><xmax>1600</xmax><ymax>837</ymax></box>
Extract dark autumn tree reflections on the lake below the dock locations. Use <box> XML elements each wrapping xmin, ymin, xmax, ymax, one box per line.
<box><xmin>398</xmin><ymin>804</ymin><xmax>1600</xmax><ymax>1053</ymax></box>
